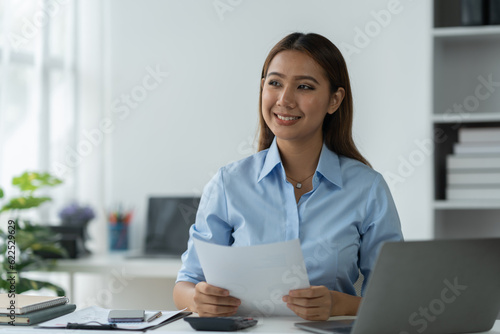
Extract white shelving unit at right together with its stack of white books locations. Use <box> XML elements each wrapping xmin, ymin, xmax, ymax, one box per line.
<box><xmin>431</xmin><ymin>0</ymin><xmax>500</xmax><ymax>238</ymax></box>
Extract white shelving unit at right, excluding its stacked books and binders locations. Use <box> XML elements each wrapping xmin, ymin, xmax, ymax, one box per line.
<box><xmin>431</xmin><ymin>0</ymin><xmax>500</xmax><ymax>238</ymax></box>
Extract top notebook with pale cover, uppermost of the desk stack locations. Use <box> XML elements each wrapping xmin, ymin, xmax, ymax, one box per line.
<box><xmin>0</xmin><ymin>293</ymin><xmax>69</xmax><ymax>314</ymax></box>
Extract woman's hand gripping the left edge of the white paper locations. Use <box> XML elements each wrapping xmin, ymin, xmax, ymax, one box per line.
<box><xmin>194</xmin><ymin>282</ymin><xmax>241</xmax><ymax>317</ymax></box>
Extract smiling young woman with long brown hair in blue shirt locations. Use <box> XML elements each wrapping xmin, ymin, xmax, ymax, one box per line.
<box><xmin>174</xmin><ymin>33</ymin><xmax>403</xmax><ymax>320</ymax></box>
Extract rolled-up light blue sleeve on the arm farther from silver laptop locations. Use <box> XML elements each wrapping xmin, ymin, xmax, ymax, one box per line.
<box><xmin>176</xmin><ymin>168</ymin><xmax>233</xmax><ymax>284</ymax></box>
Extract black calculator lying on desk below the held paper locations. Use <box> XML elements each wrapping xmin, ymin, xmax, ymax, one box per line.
<box><xmin>184</xmin><ymin>317</ymin><xmax>257</xmax><ymax>332</ymax></box>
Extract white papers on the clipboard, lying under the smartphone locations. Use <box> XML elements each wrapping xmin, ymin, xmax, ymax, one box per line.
<box><xmin>38</xmin><ymin>306</ymin><xmax>186</xmax><ymax>332</ymax></box>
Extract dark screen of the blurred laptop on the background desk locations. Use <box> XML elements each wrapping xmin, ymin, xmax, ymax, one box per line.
<box><xmin>144</xmin><ymin>197</ymin><xmax>200</xmax><ymax>255</ymax></box>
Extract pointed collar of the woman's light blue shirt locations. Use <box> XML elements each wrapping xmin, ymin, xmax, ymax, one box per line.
<box><xmin>257</xmin><ymin>137</ymin><xmax>342</xmax><ymax>188</ymax></box>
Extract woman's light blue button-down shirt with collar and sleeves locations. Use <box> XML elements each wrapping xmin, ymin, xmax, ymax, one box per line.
<box><xmin>177</xmin><ymin>140</ymin><xmax>403</xmax><ymax>295</ymax></box>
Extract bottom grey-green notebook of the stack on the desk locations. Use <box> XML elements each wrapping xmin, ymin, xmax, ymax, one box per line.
<box><xmin>0</xmin><ymin>304</ymin><xmax>76</xmax><ymax>326</ymax></box>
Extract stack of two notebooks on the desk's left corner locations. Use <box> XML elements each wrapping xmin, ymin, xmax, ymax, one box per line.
<box><xmin>0</xmin><ymin>293</ymin><xmax>76</xmax><ymax>326</ymax></box>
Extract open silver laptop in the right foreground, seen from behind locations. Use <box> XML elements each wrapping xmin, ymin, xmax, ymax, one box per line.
<box><xmin>295</xmin><ymin>239</ymin><xmax>500</xmax><ymax>334</ymax></box>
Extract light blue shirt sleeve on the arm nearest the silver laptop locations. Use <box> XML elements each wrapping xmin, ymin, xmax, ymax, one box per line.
<box><xmin>359</xmin><ymin>174</ymin><xmax>403</xmax><ymax>295</ymax></box>
